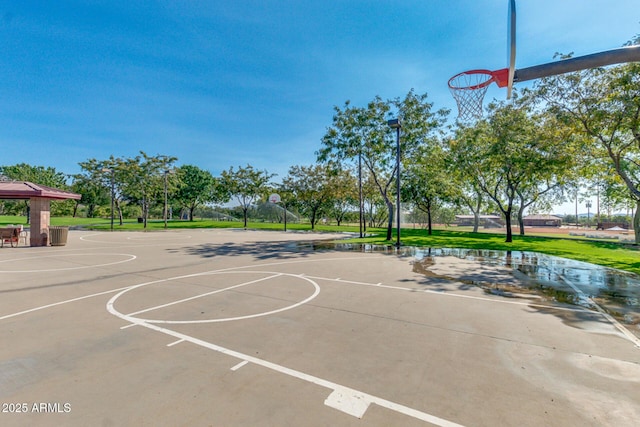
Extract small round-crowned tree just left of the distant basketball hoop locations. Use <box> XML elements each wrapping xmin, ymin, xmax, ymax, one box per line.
<box><xmin>222</xmin><ymin>165</ymin><xmax>275</xmax><ymax>229</ymax></box>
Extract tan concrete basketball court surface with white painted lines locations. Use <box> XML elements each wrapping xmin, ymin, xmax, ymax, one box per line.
<box><xmin>0</xmin><ymin>230</ymin><xmax>640</xmax><ymax>426</ymax></box>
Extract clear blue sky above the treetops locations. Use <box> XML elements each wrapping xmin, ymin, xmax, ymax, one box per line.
<box><xmin>0</xmin><ymin>0</ymin><xmax>640</xmax><ymax>212</ymax></box>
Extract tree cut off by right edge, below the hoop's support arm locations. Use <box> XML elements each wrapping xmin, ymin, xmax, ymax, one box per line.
<box><xmin>536</xmin><ymin>35</ymin><xmax>640</xmax><ymax>243</ymax></box>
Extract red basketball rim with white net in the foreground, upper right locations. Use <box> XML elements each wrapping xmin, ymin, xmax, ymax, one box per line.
<box><xmin>449</xmin><ymin>68</ymin><xmax>508</xmax><ymax>121</ymax></box>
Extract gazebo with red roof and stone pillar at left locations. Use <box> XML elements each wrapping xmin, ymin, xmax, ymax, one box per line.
<box><xmin>0</xmin><ymin>181</ymin><xmax>82</xmax><ymax>246</ymax></box>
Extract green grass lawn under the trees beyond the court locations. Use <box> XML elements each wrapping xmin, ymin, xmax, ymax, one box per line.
<box><xmin>0</xmin><ymin>216</ymin><xmax>640</xmax><ymax>274</ymax></box>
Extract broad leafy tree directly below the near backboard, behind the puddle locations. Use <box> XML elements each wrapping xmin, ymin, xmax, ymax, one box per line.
<box><xmin>450</xmin><ymin>99</ymin><xmax>570</xmax><ymax>242</ymax></box>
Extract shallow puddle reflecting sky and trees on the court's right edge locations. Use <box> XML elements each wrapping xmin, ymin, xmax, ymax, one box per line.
<box><xmin>304</xmin><ymin>242</ymin><xmax>640</xmax><ymax>334</ymax></box>
